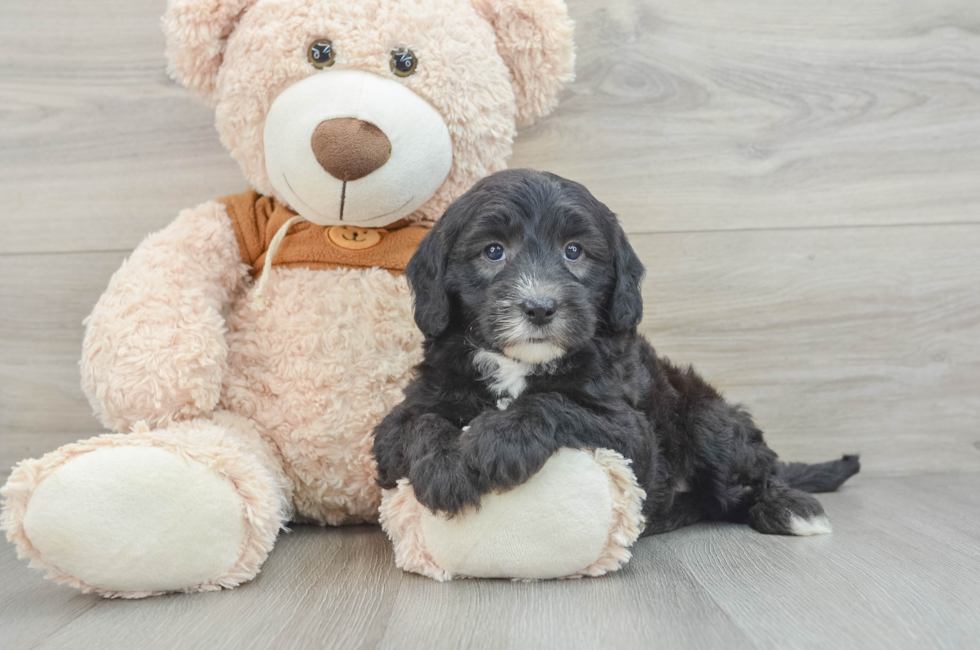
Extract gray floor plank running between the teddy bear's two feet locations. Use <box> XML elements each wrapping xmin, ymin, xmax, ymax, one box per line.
<box><xmin>27</xmin><ymin>526</ymin><xmax>403</xmax><ymax>650</ymax></box>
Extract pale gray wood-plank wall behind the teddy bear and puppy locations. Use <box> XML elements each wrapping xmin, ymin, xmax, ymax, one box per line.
<box><xmin>0</xmin><ymin>0</ymin><xmax>980</xmax><ymax>474</ymax></box>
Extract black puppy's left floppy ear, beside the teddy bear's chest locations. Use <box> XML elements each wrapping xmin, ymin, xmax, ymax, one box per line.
<box><xmin>405</xmin><ymin>222</ymin><xmax>449</xmax><ymax>338</ymax></box>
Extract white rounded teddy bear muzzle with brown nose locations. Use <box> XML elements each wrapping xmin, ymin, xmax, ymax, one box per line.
<box><xmin>263</xmin><ymin>69</ymin><xmax>453</xmax><ymax>228</ymax></box>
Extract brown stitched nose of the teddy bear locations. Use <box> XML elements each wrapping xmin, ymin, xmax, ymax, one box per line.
<box><xmin>310</xmin><ymin>117</ymin><xmax>391</xmax><ymax>181</ymax></box>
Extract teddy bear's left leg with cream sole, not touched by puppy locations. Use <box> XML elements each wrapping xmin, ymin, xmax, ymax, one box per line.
<box><xmin>0</xmin><ymin>412</ymin><xmax>289</xmax><ymax>598</ymax></box>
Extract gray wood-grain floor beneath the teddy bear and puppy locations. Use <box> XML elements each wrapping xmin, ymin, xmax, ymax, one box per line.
<box><xmin>0</xmin><ymin>473</ymin><xmax>980</xmax><ymax>650</ymax></box>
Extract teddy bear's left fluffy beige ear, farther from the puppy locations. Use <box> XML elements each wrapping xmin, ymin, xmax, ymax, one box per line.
<box><xmin>163</xmin><ymin>0</ymin><xmax>255</xmax><ymax>102</ymax></box>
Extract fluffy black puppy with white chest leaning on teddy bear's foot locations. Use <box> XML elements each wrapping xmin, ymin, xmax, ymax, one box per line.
<box><xmin>374</xmin><ymin>170</ymin><xmax>859</xmax><ymax>535</ymax></box>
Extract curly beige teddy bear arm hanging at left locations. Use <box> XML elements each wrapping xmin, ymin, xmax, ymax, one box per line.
<box><xmin>81</xmin><ymin>202</ymin><xmax>247</xmax><ymax>431</ymax></box>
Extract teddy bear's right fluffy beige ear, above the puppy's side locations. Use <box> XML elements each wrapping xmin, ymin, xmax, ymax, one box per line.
<box><xmin>472</xmin><ymin>0</ymin><xmax>575</xmax><ymax>125</ymax></box>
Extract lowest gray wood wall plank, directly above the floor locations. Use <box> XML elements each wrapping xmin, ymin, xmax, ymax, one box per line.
<box><xmin>0</xmin><ymin>225</ymin><xmax>980</xmax><ymax>473</ymax></box>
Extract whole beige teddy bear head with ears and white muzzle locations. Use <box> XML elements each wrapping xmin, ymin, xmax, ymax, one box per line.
<box><xmin>164</xmin><ymin>0</ymin><xmax>573</xmax><ymax>227</ymax></box>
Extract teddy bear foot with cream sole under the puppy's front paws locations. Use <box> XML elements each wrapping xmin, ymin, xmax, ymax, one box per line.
<box><xmin>381</xmin><ymin>449</ymin><xmax>646</xmax><ymax>580</ymax></box>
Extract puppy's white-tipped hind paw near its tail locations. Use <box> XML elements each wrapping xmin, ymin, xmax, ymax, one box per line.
<box><xmin>748</xmin><ymin>484</ymin><xmax>831</xmax><ymax>536</ymax></box>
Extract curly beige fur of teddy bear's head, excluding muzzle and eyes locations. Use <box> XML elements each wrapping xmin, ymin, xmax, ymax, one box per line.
<box><xmin>165</xmin><ymin>0</ymin><xmax>574</xmax><ymax>221</ymax></box>
